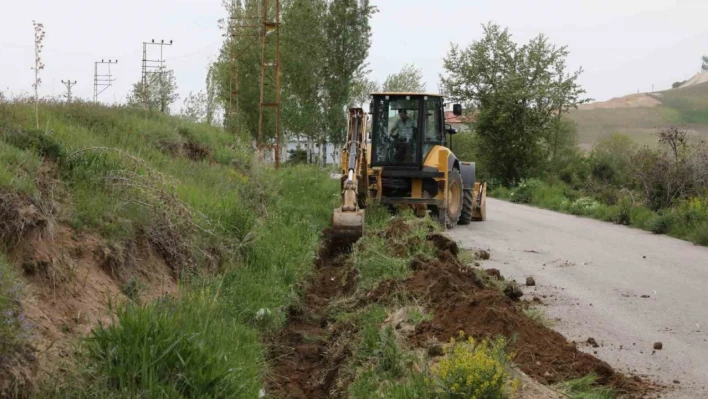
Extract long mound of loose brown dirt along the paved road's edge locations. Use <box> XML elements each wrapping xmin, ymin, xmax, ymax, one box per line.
<box><xmin>403</xmin><ymin>238</ymin><xmax>645</xmax><ymax>397</ymax></box>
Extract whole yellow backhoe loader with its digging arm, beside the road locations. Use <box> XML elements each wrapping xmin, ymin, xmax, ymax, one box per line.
<box><xmin>332</xmin><ymin>93</ymin><xmax>487</xmax><ymax>236</ymax></box>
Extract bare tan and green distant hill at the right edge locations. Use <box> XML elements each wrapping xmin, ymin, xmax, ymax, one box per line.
<box><xmin>569</xmin><ymin>74</ymin><xmax>708</xmax><ymax>149</ymax></box>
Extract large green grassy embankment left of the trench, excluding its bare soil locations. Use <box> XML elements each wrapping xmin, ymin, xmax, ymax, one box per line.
<box><xmin>0</xmin><ymin>99</ymin><xmax>337</xmax><ymax>398</ymax></box>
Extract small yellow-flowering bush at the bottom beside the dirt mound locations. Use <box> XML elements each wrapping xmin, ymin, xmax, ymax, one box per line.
<box><xmin>432</xmin><ymin>337</ymin><xmax>518</xmax><ymax>399</ymax></box>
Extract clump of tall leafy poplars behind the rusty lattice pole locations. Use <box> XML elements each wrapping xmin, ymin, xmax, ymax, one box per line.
<box><xmin>213</xmin><ymin>0</ymin><xmax>375</xmax><ymax>164</ymax></box>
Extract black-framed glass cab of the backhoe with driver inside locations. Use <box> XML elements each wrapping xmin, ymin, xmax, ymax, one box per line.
<box><xmin>370</xmin><ymin>93</ymin><xmax>462</xmax><ymax>170</ymax></box>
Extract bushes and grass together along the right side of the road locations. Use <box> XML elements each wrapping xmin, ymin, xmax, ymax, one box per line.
<box><xmin>491</xmin><ymin>128</ymin><xmax>708</xmax><ymax>245</ymax></box>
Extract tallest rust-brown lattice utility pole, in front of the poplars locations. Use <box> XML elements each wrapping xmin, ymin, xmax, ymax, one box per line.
<box><xmin>258</xmin><ymin>0</ymin><xmax>281</xmax><ymax>169</ymax></box>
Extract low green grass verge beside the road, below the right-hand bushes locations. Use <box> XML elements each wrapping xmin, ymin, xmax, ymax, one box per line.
<box><xmin>490</xmin><ymin>179</ymin><xmax>708</xmax><ymax>245</ymax></box>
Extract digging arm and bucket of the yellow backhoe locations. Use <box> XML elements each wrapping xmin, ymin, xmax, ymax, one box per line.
<box><xmin>332</xmin><ymin>108</ymin><xmax>368</xmax><ymax>238</ymax></box>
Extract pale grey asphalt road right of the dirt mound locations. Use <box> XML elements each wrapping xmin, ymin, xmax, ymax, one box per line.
<box><xmin>449</xmin><ymin>198</ymin><xmax>708</xmax><ymax>398</ymax></box>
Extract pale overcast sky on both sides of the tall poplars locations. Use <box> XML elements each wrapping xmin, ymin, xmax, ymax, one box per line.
<box><xmin>0</xmin><ymin>0</ymin><xmax>708</xmax><ymax>108</ymax></box>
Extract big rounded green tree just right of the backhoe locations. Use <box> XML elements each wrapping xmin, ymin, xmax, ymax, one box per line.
<box><xmin>441</xmin><ymin>23</ymin><xmax>590</xmax><ymax>185</ymax></box>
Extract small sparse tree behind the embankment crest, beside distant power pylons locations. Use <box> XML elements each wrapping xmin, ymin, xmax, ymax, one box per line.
<box><xmin>128</xmin><ymin>70</ymin><xmax>179</xmax><ymax>113</ymax></box>
